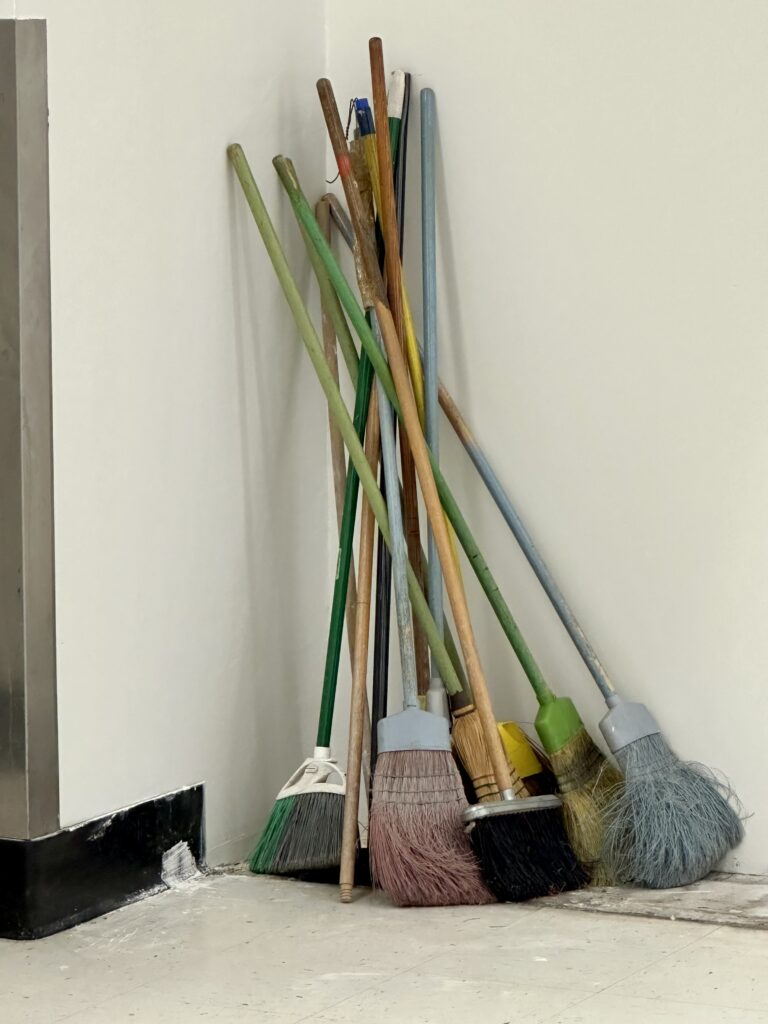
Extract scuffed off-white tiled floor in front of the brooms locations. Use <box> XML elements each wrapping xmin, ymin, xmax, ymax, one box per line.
<box><xmin>0</xmin><ymin>876</ymin><xmax>768</xmax><ymax>1024</ymax></box>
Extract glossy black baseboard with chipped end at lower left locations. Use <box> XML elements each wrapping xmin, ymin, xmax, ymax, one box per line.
<box><xmin>0</xmin><ymin>785</ymin><xmax>203</xmax><ymax>939</ymax></box>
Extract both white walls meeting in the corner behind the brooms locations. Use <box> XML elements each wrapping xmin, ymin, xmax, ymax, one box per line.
<box><xmin>7</xmin><ymin>0</ymin><xmax>768</xmax><ymax>871</ymax></box>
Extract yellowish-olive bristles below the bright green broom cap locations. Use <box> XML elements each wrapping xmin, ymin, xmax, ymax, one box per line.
<box><xmin>550</xmin><ymin>729</ymin><xmax>622</xmax><ymax>886</ymax></box>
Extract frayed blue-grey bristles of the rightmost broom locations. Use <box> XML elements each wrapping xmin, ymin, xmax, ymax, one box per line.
<box><xmin>604</xmin><ymin>733</ymin><xmax>743</xmax><ymax>889</ymax></box>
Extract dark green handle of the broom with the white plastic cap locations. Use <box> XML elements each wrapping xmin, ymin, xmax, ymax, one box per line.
<box><xmin>315</xmin><ymin>352</ymin><xmax>374</xmax><ymax>746</ymax></box>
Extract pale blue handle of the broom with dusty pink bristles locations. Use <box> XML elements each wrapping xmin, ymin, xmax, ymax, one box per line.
<box><xmin>371</xmin><ymin>313</ymin><xmax>419</xmax><ymax>708</ymax></box>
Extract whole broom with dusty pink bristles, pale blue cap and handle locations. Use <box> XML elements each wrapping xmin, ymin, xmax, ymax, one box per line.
<box><xmin>369</xmin><ymin>319</ymin><xmax>493</xmax><ymax>906</ymax></box>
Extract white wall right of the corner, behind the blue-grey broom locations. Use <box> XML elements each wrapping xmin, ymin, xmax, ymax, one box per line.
<box><xmin>329</xmin><ymin>0</ymin><xmax>768</xmax><ymax>872</ymax></box>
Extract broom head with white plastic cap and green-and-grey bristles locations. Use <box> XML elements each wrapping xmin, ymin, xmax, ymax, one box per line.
<box><xmin>250</xmin><ymin>746</ymin><xmax>346</xmax><ymax>874</ymax></box>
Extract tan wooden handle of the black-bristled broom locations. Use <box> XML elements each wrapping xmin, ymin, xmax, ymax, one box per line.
<box><xmin>376</xmin><ymin>299</ymin><xmax>512</xmax><ymax>795</ymax></box>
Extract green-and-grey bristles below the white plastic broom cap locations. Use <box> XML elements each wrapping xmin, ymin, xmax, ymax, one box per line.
<box><xmin>251</xmin><ymin>793</ymin><xmax>344</xmax><ymax>874</ymax></box>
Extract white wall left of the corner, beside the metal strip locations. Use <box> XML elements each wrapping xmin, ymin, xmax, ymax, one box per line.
<box><xmin>9</xmin><ymin>0</ymin><xmax>331</xmax><ymax>861</ymax></box>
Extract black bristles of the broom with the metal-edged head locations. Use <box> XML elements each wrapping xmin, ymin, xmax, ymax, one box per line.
<box><xmin>469</xmin><ymin>798</ymin><xmax>588</xmax><ymax>903</ymax></box>
